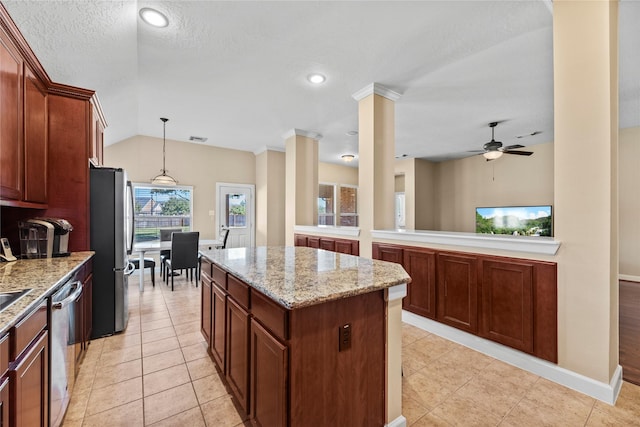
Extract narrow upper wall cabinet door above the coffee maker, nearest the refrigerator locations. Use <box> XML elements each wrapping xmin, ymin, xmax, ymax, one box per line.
<box><xmin>24</xmin><ymin>67</ymin><xmax>47</xmax><ymax>203</ymax></box>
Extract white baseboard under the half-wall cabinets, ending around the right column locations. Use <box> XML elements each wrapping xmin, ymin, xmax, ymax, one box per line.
<box><xmin>402</xmin><ymin>310</ymin><xmax>622</xmax><ymax>405</ymax></box>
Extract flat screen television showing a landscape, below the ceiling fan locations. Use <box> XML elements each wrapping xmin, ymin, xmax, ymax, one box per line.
<box><xmin>476</xmin><ymin>205</ymin><xmax>553</xmax><ymax>236</ymax></box>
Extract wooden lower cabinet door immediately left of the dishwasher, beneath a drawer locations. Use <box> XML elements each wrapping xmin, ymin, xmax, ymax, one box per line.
<box><xmin>9</xmin><ymin>331</ymin><xmax>49</xmax><ymax>427</ymax></box>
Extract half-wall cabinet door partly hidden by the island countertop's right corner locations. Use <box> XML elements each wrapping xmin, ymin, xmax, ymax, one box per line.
<box><xmin>402</xmin><ymin>249</ymin><xmax>436</xmax><ymax>319</ymax></box>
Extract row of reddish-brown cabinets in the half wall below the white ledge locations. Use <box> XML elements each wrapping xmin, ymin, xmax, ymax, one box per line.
<box><xmin>372</xmin><ymin>242</ymin><xmax>558</xmax><ymax>363</ymax></box>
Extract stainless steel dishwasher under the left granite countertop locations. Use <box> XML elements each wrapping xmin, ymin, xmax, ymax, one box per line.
<box><xmin>49</xmin><ymin>279</ymin><xmax>82</xmax><ymax>427</ymax></box>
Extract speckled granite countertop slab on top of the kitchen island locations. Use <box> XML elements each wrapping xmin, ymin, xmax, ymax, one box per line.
<box><xmin>201</xmin><ymin>246</ymin><xmax>411</xmax><ymax>309</ymax></box>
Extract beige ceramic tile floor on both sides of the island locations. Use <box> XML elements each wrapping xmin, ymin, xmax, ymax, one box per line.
<box><xmin>63</xmin><ymin>276</ymin><xmax>640</xmax><ymax>427</ymax></box>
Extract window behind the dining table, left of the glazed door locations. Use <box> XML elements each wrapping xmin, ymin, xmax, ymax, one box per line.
<box><xmin>133</xmin><ymin>183</ymin><xmax>193</xmax><ymax>242</ymax></box>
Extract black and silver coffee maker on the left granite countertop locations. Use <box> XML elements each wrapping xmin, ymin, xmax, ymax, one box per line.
<box><xmin>18</xmin><ymin>218</ymin><xmax>73</xmax><ymax>258</ymax></box>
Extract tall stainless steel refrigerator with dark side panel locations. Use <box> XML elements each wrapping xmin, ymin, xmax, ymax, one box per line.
<box><xmin>90</xmin><ymin>167</ymin><xmax>133</xmax><ymax>338</ymax></box>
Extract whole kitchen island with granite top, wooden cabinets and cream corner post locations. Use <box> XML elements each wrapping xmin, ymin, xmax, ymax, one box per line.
<box><xmin>201</xmin><ymin>247</ymin><xmax>411</xmax><ymax>426</ymax></box>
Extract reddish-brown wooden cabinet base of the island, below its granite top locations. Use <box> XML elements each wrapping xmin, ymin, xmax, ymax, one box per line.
<box><xmin>202</xmin><ymin>265</ymin><xmax>386</xmax><ymax>427</ymax></box>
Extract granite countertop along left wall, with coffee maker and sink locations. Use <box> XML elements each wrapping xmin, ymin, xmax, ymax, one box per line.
<box><xmin>0</xmin><ymin>252</ymin><xmax>93</xmax><ymax>334</ymax></box>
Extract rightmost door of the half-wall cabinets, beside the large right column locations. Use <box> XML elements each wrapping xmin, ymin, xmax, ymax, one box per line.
<box><xmin>479</xmin><ymin>259</ymin><xmax>533</xmax><ymax>353</ymax></box>
